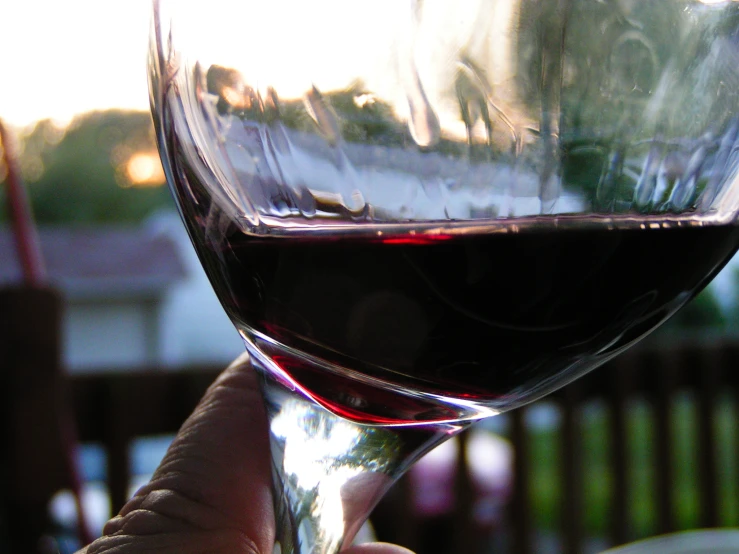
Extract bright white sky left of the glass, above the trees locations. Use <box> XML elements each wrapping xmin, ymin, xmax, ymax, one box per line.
<box><xmin>0</xmin><ymin>0</ymin><xmax>151</xmax><ymax>127</ymax></box>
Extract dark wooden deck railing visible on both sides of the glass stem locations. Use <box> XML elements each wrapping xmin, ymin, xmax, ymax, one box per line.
<box><xmin>71</xmin><ymin>343</ymin><xmax>739</xmax><ymax>554</ymax></box>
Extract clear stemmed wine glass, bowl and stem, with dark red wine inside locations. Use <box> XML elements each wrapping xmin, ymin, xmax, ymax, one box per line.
<box><xmin>149</xmin><ymin>0</ymin><xmax>739</xmax><ymax>554</ymax></box>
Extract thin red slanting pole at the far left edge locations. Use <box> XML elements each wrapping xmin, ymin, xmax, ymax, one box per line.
<box><xmin>0</xmin><ymin>120</ymin><xmax>93</xmax><ymax>546</ymax></box>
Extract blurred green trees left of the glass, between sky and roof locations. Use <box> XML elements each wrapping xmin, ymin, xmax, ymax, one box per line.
<box><xmin>0</xmin><ymin>111</ymin><xmax>171</xmax><ymax>224</ymax></box>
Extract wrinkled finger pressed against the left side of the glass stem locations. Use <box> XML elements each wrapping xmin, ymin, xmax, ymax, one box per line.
<box><xmin>114</xmin><ymin>354</ymin><xmax>274</xmax><ymax>552</ymax></box>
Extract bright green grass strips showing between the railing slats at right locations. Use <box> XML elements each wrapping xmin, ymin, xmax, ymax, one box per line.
<box><xmin>530</xmin><ymin>395</ymin><xmax>739</xmax><ymax>539</ymax></box>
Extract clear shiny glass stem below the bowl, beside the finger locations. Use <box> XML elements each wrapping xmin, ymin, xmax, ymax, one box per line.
<box><xmin>255</xmin><ymin>361</ymin><xmax>465</xmax><ymax>554</ymax></box>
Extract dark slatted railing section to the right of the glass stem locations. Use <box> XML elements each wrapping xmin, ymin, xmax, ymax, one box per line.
<box><xmin>381</xmin><ymin>340</ymin><xmax>739</xmax><ymax>554</ymax></box>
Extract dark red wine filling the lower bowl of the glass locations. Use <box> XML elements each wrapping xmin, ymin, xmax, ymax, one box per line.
<box><xmin>186</xmin><ymin>205</ymin><xmax>739</xmax><ymax>424</ymax></box>
